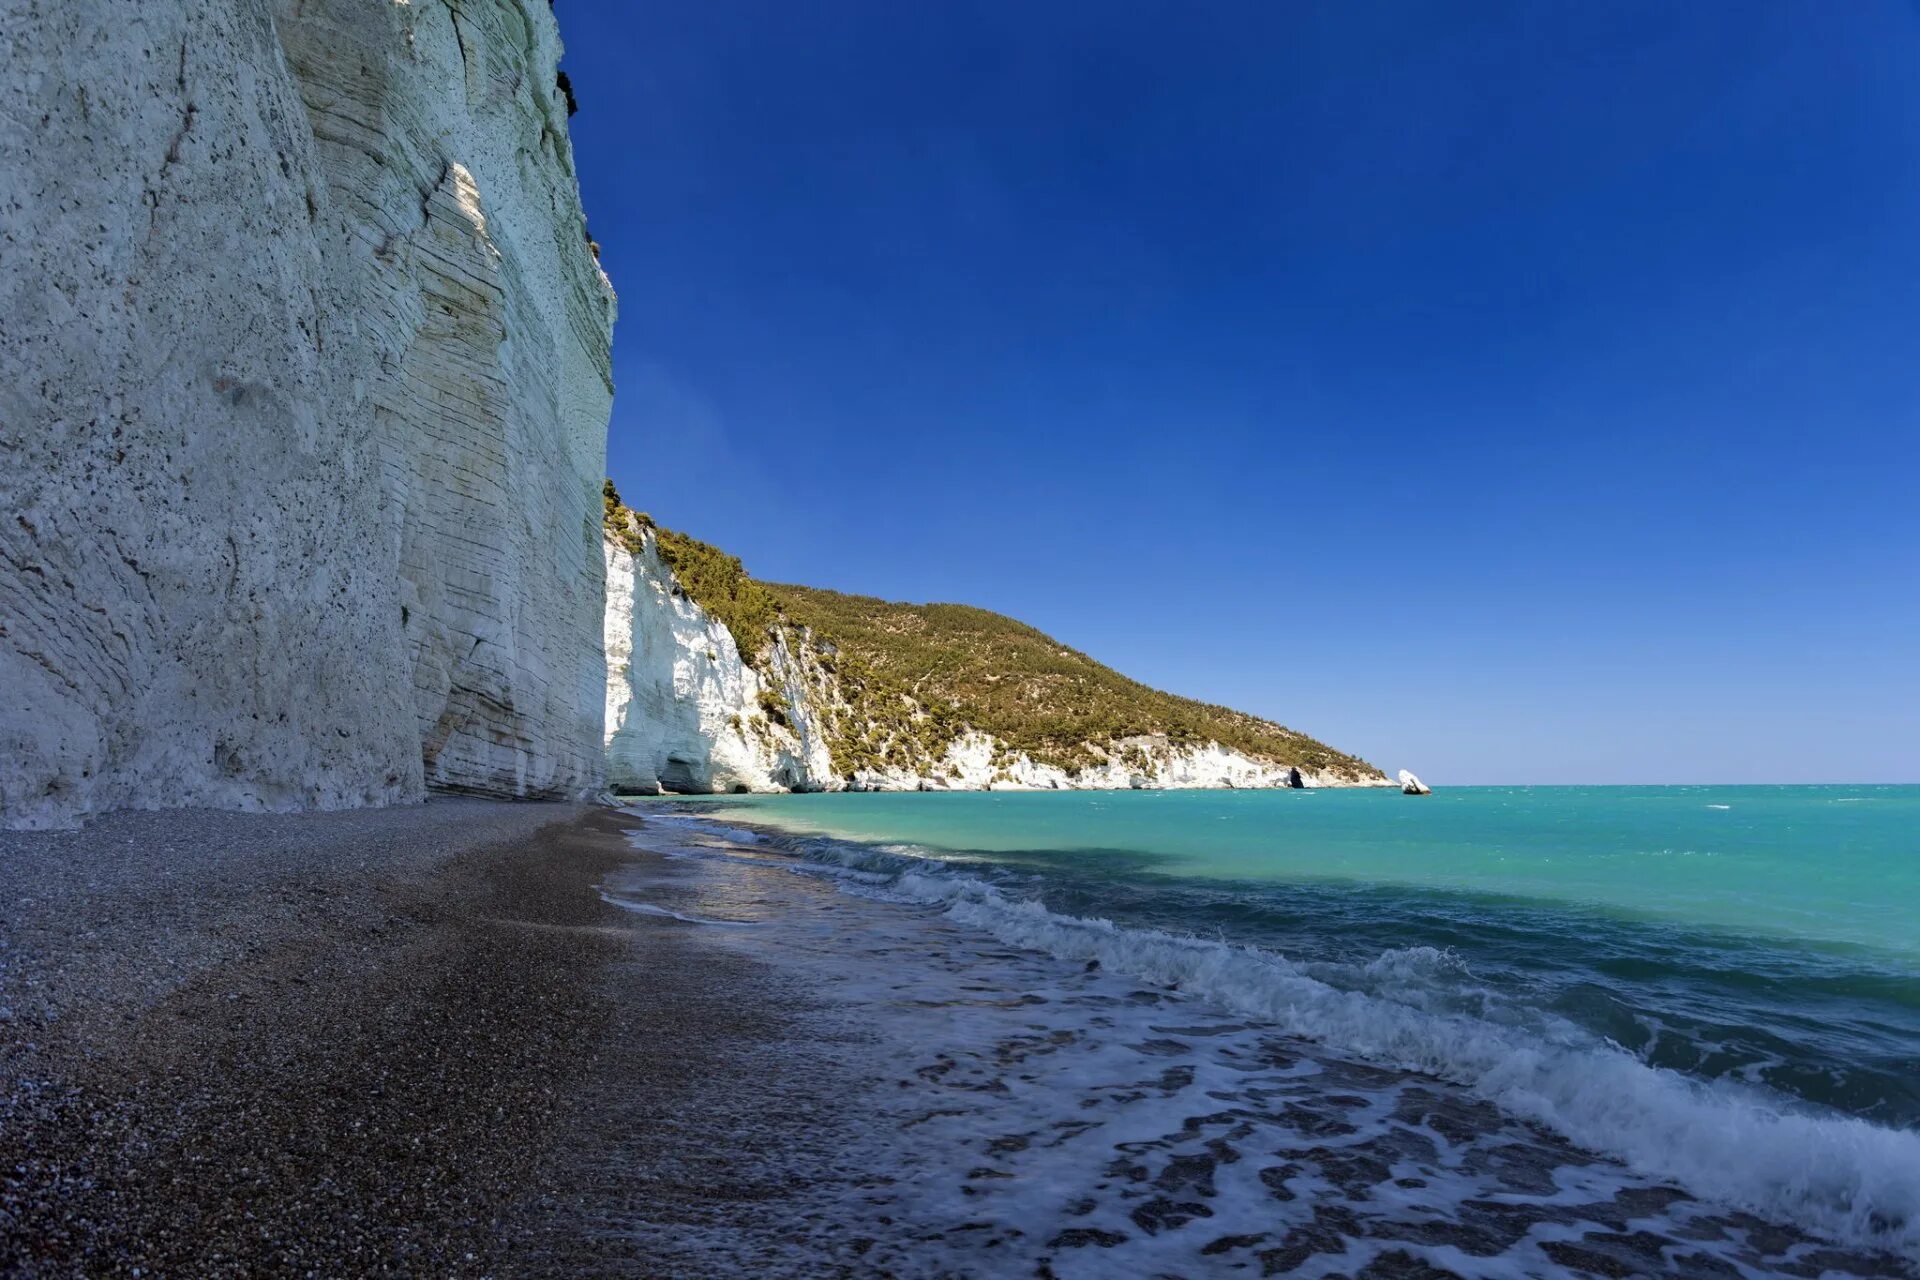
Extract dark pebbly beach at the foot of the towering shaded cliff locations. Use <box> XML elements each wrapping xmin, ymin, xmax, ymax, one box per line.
<box><xmin>0</xmin><ymin>800</ymin><xmax>814</xmax><ymax>1276</ymax></box>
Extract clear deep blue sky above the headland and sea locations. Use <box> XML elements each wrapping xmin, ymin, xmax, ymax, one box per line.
<box><xmin>557</xmin><ymin>0</ymin><xmax>1920</xmax><ymax>783</ymax></box>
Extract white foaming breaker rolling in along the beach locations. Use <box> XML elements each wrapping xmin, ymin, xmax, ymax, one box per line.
<box><xmin>689</xmin><ymin>823</ymin><xmax>1920</xmax><ymax>1255</ymax></box>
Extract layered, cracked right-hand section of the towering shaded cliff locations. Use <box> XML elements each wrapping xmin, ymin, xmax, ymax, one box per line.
<box><xmin>278</xmin><ymin>0</ymin><xmax>612</xmax><ymax>796</ymax></box>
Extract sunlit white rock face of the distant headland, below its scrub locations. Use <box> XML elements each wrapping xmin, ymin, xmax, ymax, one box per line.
<box><xmin>605</xmin><ymin>529</ymin><xmax>1390</xmax><ymax>794</ymax></box>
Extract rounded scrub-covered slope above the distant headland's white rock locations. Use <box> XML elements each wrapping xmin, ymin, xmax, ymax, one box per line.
<box><xmin>766</xmin><ymin>583</ymin><xmax>1375</xmax><ymax>773</ymax></box>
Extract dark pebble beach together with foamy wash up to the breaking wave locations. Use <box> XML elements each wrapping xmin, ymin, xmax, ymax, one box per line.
<box><xmin>0</xmin><ymin>800</ymin><xmax>1914</xmax><ymax>1280</ymax></box>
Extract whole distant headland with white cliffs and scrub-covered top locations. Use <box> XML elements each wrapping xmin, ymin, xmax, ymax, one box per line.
<box><xmin>605</xmin><ymin>484</ymin><xmax>1392</xmax><ymax>793</ymax></box>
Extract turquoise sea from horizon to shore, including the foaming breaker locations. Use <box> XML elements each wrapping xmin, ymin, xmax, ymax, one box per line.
<box><xmin>670</xmin><ymin>785</ymin><xmax>1920</xmax><ymax>1240</ymax></box>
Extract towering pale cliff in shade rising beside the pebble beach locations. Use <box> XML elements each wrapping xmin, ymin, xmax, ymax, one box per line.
<box><xmin>0</xmin><ymin>0</ymin><xmax>612</xmax><ymax>825</ymax></box>
